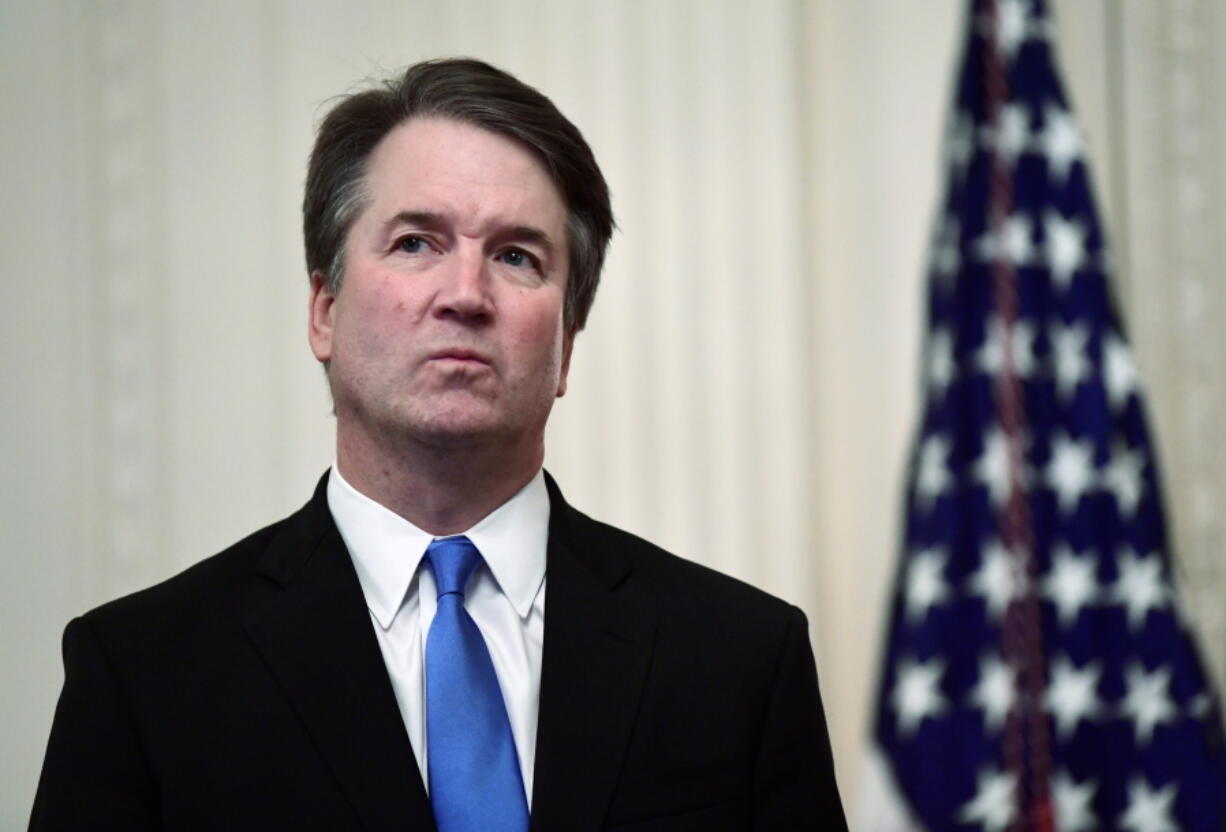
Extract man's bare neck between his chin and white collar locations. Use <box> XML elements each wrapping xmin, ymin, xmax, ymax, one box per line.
<box><xmin>336</xmin><ymin>434</ymin><xmax>544</xmax><ymax>537</ymax></box>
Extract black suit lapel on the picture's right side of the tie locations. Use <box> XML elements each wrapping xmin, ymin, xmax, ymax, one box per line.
<box><xmin>532</xmin><ymin>479</ymin><xmax>656</xmax><ymax>831</ymax></box>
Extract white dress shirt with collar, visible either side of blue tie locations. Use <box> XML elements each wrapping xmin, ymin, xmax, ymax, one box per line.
<box><xmin>327</xmin><ymin>464</ymin><xmax>549</xmax><ymax>809</ymax></box>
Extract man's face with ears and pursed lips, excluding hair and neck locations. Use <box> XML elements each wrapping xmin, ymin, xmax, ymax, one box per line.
<box><xmin>310</xmin><ymin>119</ymin><xmax>573</xmax><ymax>447</ymax></box>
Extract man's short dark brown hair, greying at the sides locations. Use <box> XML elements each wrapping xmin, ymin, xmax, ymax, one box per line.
<box><xmin>303</xmin><ymin>59</ymin><xmax>613</xmax><ymax>336</ymax></box>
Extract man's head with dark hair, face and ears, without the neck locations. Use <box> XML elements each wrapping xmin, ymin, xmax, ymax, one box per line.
<box><xmin>304</xmin><ymin>60</ymin><xmax>612</xmax><ymax>465</ymax></box>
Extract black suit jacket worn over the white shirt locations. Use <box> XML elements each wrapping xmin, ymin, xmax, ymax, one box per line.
<box><xmin>31</xmin><ymin>477</ymin><xmax>846</xmax><ymax>832</ymax></box>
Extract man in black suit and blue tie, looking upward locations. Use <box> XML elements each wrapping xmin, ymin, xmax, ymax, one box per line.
<box><xmin>31</xmin><ymin>60</ymin><xmax>845</xmax><ymax>832</ymax></box>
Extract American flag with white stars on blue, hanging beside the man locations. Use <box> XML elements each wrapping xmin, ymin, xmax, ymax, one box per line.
<box><xmin>874</xmin><ymin>0</ymin><xmax>1226</xmax><ymax>832</ymax></box>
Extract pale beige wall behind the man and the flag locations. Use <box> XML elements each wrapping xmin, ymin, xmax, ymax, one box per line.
<box><xmin>0</xmin><ymin>0</ymin><xmax>1226</xmax><ymax>828</ymax></box>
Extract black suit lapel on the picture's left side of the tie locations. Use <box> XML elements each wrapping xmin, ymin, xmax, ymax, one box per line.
<box><xmin>246</xmin><ymin>477</ymin><xmax>434</xmax><ymax>830</ymax></box>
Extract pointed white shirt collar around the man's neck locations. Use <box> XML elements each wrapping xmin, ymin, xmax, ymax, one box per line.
<box><xmin>327</xmin><ymin>463</ymin><xmax>549</xmax><ymax>630</ymax></box>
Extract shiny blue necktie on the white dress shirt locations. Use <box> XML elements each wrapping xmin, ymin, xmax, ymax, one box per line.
<box><xmin>425</xmin><ymin>537</ymin><xmax>528</xmax><ymax>832</ymax></box>
